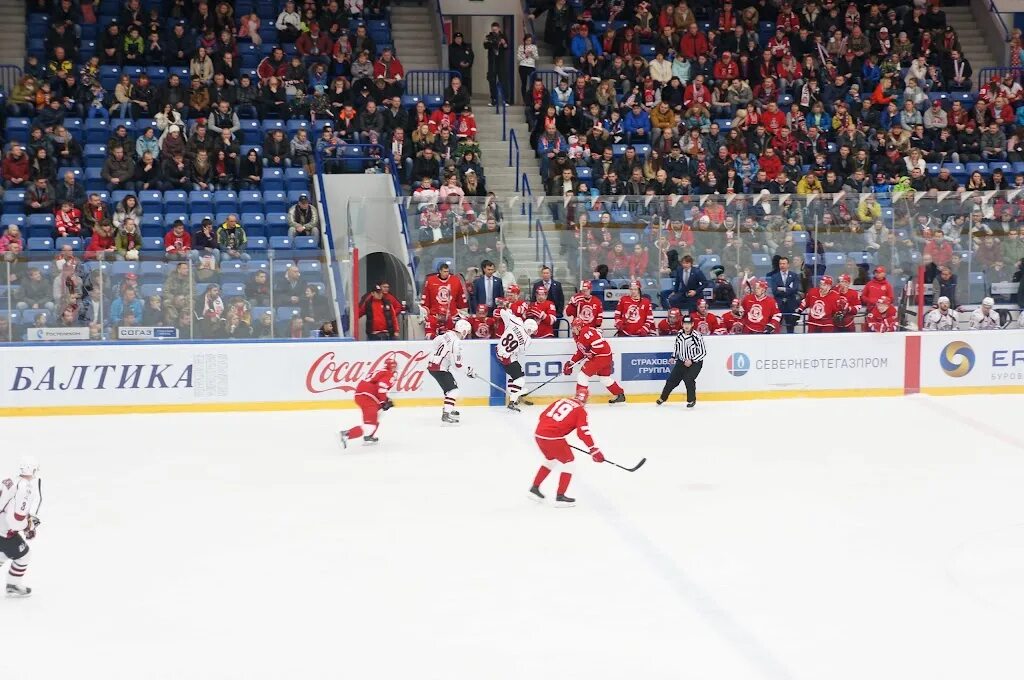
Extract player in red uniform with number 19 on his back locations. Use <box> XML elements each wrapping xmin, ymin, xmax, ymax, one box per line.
<box><xmin>529</xmin><ymin>393</ymin><xmax>604</xmax><ymax>508</ymax></box>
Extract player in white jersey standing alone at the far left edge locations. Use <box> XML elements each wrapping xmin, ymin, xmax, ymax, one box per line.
<box><xmin>0</xmin><ymin>459</ymin><xmax>43</xmax><ymax>597</ymax></box>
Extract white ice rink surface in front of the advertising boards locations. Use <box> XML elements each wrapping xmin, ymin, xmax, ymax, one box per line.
<box><xmin>0</xmin><ymin>390</ymin><xmax>1024</xmax><ymax>680</ymax></box>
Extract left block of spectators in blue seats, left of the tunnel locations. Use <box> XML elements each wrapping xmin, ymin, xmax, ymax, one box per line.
<box><xmin>0</xmin><ymin>0</ymin><xmax>395</xmax><ymax>339</ymax></box>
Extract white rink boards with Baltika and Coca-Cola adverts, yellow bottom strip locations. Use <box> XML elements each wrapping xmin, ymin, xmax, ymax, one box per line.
<box><xmin>0</xmin><ymin>331</ymin><xmax>1024</xmax><ymax>416</ymax></box>
